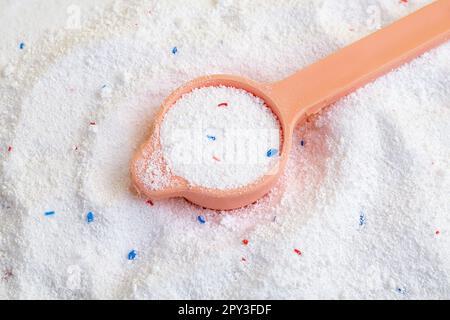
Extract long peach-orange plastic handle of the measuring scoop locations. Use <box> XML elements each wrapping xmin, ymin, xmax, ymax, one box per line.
<box><xmin>270</xmin><ymin>0</ymin><xmax>450</xmax><ymax>127</ymax></box>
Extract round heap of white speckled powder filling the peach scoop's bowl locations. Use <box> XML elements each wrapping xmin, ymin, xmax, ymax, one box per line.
<box><xmin>160</xmin><ymin>87</ymin><xmax>280</xmax><ymax>189</ymax></box>
